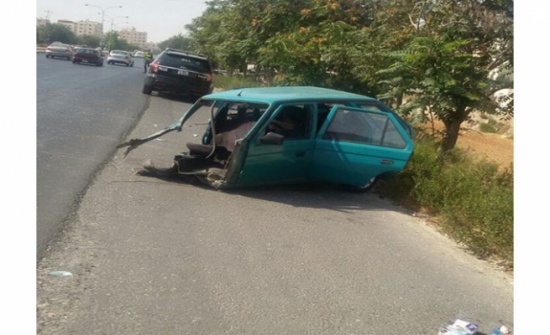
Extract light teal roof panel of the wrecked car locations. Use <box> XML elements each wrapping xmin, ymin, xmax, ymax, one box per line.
<box><xmin>203</xmin><ymin>86</ymin><xmax>377</xmax><ymax>104</ymax></box>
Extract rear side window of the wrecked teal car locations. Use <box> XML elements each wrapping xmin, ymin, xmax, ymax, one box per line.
<box><xmin>323</xmin><ymin>109</ymin><xmax>406</xmax><ymax>148</ymax></box>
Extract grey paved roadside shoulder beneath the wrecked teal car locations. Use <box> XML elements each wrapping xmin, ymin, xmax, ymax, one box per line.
<box><xmin>37</xmin><ymin>95</ymin><xmax>514</xmax><ymax>335</ymax></box>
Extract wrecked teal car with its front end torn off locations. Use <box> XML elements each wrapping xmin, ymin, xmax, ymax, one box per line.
<box><xmin>118</xmin><ymin>86</ymin><xmax>414</xmax><ymax>191</ymax></box>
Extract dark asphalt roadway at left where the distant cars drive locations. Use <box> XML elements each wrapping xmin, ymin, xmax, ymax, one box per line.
<box><xmin>36</xmin><ymin>54</ymin><xmax>148</xmax><ymax>257</ymax></box>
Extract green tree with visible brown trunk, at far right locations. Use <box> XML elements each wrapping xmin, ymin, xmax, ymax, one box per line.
<box><xmin>382</xmin><ymin>0</ymin><xmax>513</xmax><ymax>152</ymax></box>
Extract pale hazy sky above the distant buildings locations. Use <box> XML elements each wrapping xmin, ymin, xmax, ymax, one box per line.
<box><xmin>36</xmin><ymin>0</ymin><xmax>210</xmax><ymax>43</ymax></box>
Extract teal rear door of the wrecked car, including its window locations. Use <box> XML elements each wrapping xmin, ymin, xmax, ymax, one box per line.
<box><xmin>308</xmin><ymin>106</ymin><xmax>414</xmax><ymax>187</ymax></box>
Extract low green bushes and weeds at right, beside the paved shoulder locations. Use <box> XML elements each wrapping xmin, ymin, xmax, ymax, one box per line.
<box><xmin>379</xmin><ymin>140</ymin><xmax>514</xmax><ymax>266</ymax></box>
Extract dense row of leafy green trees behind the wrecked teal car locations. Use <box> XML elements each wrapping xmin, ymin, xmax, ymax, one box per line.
<box><xmin>181</xmin><ymin>0</ymin><xmax>513</xmax><ymax>151</ymax></box>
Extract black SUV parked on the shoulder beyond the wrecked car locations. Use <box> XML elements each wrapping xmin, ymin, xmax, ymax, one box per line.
<box><xmin>142</xmin><ymin>48</ymin><xmax>214</xmax><ymax>98</ymax></box>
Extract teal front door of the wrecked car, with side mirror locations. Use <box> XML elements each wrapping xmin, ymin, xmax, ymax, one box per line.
<box><xmin>238</xmin><ymin>103</ymin><xmax>315</xmax><ymax>185</ymax></box>
